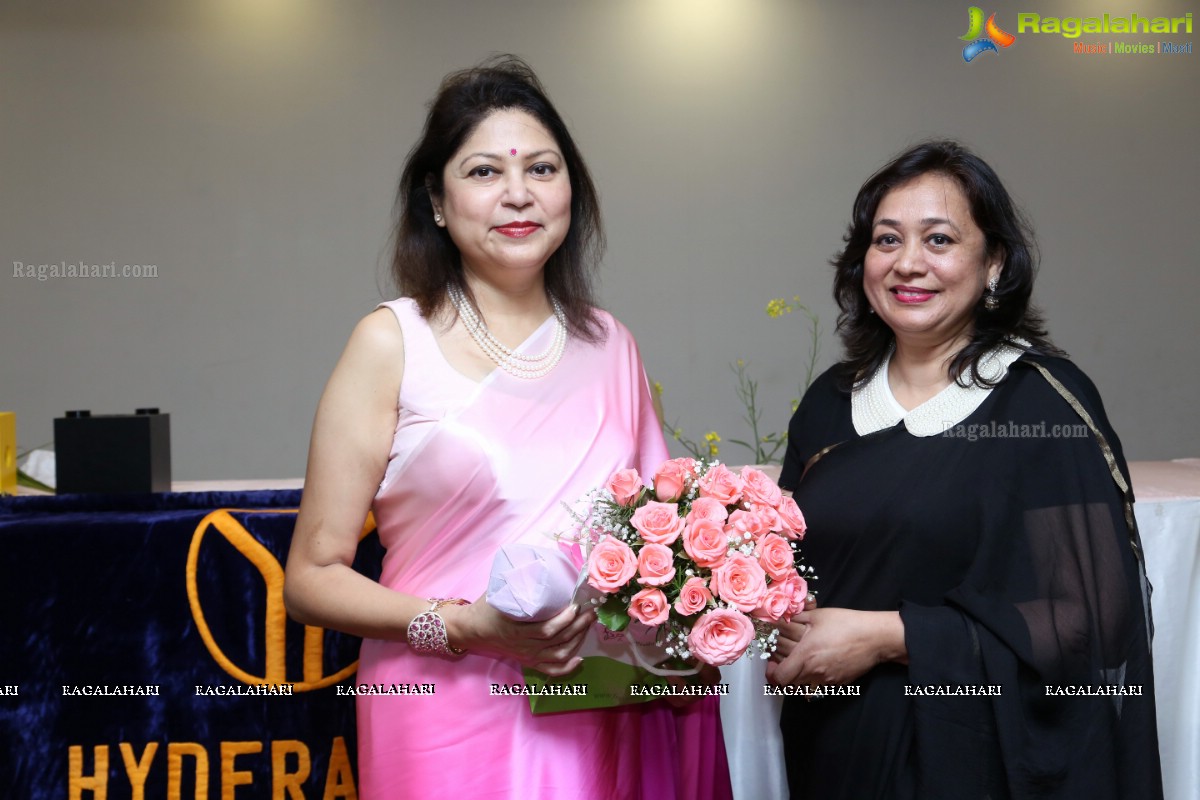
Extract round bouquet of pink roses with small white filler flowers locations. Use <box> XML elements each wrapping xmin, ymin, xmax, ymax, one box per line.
<box><xmin>576</xmin><ymin>458</ymin><xmax>814</xmax><ymax>667</ymax></box>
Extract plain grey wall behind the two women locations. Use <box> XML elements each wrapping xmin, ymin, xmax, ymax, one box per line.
<box><xmin>0</xmin><ymin>0</ymin><xmax>1200</xmax><ymax>480</ymax></box>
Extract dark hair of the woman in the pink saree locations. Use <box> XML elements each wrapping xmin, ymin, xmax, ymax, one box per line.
<box><xmin>391</xmin><ymin>55</ymin><xmax>605</xmax><ymax>342</ymax></box>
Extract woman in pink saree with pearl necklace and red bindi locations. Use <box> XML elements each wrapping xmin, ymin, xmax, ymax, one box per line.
<box><xmin>284</xmin><ymin>56</ymin><xmax>731</xmax><ymax>800</ymax></box>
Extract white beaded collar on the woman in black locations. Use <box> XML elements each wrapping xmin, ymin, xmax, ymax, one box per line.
<box><xmin>851</xmin><ymin>338</ymin><xmax>1030</xmax><ymax>437</ymax></box>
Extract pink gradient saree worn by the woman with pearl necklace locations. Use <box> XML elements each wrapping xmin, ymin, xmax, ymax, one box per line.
<box><xmin>356</xmin><ymin>299</ymin><xmax>731</xmax><ymax>800</ymax></box>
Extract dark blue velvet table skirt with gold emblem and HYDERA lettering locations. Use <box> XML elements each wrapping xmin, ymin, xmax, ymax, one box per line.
<box><xmin>0</xmin><ymin>491</ymin><xmax>382</xmax><ymax>800</ymax></box>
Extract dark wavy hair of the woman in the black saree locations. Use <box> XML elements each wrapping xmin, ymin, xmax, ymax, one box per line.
<box><xmin>830</xmin><ymin>140</ymin><xmax>1066</xmax><ymax>387</ymax></box>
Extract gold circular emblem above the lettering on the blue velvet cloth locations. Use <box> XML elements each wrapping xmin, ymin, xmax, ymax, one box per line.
<box><xmin>187</xmin><ymin>509</ymin><xmax>376</xmax><ymax>692</ymax></box>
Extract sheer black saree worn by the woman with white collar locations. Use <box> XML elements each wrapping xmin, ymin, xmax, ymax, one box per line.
<box><xmin>780</xmin><ymin>355</ymin><xmax>1162</xmax><ymax>800</ymax></box>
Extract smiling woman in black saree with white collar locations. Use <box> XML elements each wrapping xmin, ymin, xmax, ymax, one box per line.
<box><xmin>768</xmin><ymin>142</ymin><xmax>1162</xmax><ymax>800</ymax></box>
